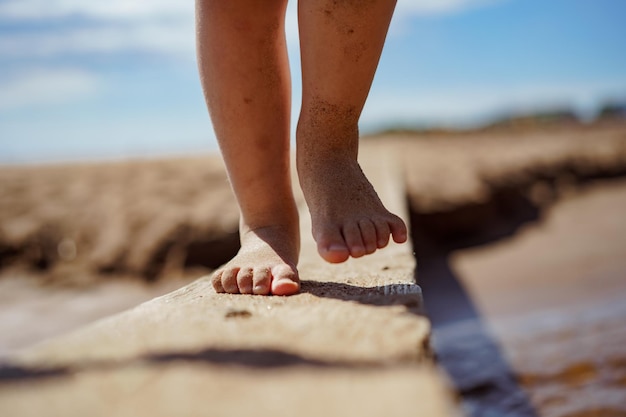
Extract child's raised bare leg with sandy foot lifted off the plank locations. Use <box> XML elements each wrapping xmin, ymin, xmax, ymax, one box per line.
<box><xmin>297</xmin><ymin>0</ymin><xmax>407</xmax><ymax>262</ymax></box>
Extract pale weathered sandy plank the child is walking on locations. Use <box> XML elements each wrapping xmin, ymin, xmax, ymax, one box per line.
<box><xmin>0</xmin><ymin>142</ymin><xmax>458</xmax><ymax>417</ymax></box>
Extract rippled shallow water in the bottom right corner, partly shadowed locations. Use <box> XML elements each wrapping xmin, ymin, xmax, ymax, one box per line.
<box><xmin>433</xmin><ymin>297</ymin><xmax>626</xmax><ymax>417</ymax></box>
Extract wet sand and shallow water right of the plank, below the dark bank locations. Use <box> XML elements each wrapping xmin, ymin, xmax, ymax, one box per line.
<box><xmin>418</xmin><ymin>180</ymin><xmax>626</xmax><ymax>417</ymax></box>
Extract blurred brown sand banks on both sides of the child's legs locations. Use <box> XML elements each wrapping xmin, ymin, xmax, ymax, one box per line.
<box><xmin>0</xmin><ymin>123</ymin><xmax>626</xmax><ymax>283</ymax></box>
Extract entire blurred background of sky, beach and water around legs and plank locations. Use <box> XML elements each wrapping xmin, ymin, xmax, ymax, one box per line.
<box><xmin>0</xmin><ymin>0</ymin><xmax>626</xmax><ymax>417</ymax></box>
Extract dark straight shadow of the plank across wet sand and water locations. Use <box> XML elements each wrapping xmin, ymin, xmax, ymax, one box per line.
<box><xmin>417</xmin><ymin>250</ymin><xmax>538</xmax><ymax>417</ymax></box>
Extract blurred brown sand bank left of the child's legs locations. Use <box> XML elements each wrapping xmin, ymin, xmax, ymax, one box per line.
<box><xmin>0</xmin><ymin>155</ymin><xmax>238</xmax><ymax>282</ymax></box>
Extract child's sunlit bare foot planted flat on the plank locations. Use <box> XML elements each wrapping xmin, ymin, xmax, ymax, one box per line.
<box><xmin>212</xmin><ymin>226</ymin><xmax>300</xmax><ymax>295</ymax></box>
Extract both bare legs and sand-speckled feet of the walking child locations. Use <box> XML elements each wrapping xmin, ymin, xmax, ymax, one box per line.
<box><xmin>196</xmin><ymin>0</ymin><xmax>407</xmax><ymax>295</ymax></box>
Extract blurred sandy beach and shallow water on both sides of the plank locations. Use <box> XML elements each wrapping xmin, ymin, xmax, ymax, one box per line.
<box><xmin>0</xmin><ymin>122</ymin><xmax>626</xmax><ymax>416</ymax></box>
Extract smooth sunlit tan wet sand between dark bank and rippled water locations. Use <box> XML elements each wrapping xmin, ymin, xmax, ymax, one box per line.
<box><xmin>452</xmin><ymin>180</ymin><xmax>626</xmax><ymax>317</ymax></box>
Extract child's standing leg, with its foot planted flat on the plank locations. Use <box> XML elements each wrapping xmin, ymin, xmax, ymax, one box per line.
<box><xmin>196</xmin><ymin>0</ymin><xmax>300</xmax><ymax>295</ymax></box>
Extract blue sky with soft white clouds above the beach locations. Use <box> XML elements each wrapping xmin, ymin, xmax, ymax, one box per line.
<box><xmin>0</xmin><ymin>0</ymin><xmax>626</xmax><ymax>164</ymax></box>
